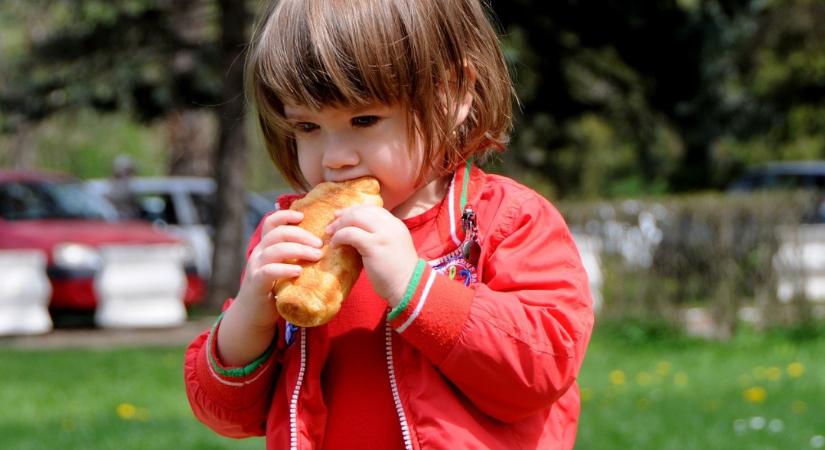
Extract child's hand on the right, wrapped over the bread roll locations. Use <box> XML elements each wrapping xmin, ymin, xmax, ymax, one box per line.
<box><xmin>327</xmin><ymin>206</ymin><xmax>418</xmax><ymax>307</ymax></box>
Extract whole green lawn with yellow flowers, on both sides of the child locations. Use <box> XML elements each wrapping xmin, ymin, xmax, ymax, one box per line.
<box><xmin>0</xmin><ymin>326</ymin><xmax>825</xmax><ymax>450</ymax></box>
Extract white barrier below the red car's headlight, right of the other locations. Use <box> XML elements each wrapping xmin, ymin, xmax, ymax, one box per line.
<box><xmin>95</xmin><ymin>245</ymin><xmax>186</xmax><ymax>328</ymax></box>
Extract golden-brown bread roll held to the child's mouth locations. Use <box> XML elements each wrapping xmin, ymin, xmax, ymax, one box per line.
<box><xmin>272</xmin><ymin>177</ymin><xmax>383</xmax><ymax>327</ymax></box>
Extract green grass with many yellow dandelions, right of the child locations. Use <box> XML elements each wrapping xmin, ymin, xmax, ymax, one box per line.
<box><xmin>577</xmin><ymin>326</ymin><xmax>825</xmax><ymax>450</ymax></box>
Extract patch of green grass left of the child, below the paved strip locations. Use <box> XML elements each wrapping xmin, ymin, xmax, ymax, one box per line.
<box><xmin>0</xmin><ymin>348</ymin><xmax>264</xmax><ymax>450</ymax></box>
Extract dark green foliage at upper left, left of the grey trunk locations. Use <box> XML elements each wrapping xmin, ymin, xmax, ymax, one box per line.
<box><xmin>0</xmin><ymin>0</ymin><xmax>226</xmax><ymax>131</ymax></box>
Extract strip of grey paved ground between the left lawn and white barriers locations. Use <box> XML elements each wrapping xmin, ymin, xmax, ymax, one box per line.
<box><xmin>0</xmin><ymin>317</ymin><xmax>215</xmax><ymax>349</ymax></box>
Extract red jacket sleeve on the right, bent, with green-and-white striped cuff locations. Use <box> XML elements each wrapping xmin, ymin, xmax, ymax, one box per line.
<box><xmin>390</xmin><ymin>195</ymin><xmax>594</xmax><ymax>422</ymax></box>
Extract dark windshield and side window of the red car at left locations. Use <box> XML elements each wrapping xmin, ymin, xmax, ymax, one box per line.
<box><xmin>0</xmin><ymin>182</ymin><xmax>115</xmax><ymax>220</ymax></box>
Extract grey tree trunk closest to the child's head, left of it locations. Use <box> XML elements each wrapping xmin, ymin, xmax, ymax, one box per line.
<box><xmin>207</xmin><ymin>0</ymin><xmax>248</xmax><ymax>308</ymax></box>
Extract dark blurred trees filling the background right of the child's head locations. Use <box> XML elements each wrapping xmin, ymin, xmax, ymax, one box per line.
<box><xmin>492</xmin><ymin>0</ymin><xmax>825</xmax><ymax>197</ymax></box>
